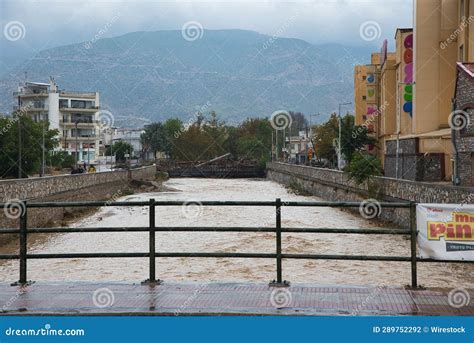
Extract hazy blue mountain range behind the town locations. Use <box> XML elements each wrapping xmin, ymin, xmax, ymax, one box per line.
<box><xmin>0</xmin><ymin>30</ymin><xmax>370</xmax><ymax>127</ymax></box>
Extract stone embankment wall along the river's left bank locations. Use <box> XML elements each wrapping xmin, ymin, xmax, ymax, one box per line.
<box><xmin>0</xmin><ymin>166</ymin><xmax>156</xmax><ymax>234</ymax></box>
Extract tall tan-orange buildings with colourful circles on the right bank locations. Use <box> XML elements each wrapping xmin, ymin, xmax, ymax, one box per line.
<box><xmin>354</xmin><ymin>0</ymin><xmax>474</xmax><ymax>185</ymax></box>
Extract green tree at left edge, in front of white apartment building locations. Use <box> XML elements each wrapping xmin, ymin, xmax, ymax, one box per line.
<box><xmin>0</xmin><ymin>117</ymin><xmax>59</xmax><ymax>177</ymax></box>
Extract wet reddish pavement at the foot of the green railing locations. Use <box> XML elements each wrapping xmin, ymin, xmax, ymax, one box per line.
<box><xmin>0</xmin><ymin>282</ymin><xmax>474</xmax><ymax>316</ymax></box>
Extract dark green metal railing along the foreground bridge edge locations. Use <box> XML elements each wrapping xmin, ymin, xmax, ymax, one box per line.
<box><xmin>0</xmin><ymin>199</ymin><xmax>470</xmax><ymax>288</ymax></box>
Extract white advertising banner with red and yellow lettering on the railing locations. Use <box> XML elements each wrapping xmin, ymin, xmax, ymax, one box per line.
<box><xmin>416</xmin><ymin>204</ymin><xmax>474</xmax><ymax>261</ymax></box>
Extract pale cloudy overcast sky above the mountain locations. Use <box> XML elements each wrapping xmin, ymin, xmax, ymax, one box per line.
<box><xmin>0</xmin><ymin>0</ymin><xmax>413</xmax><ymax>67</ymax></box>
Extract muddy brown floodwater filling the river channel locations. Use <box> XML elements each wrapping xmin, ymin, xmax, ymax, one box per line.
<box><xmin>0</xmin><ymin>179</ymin><xmax>474</xmax><ymax>288</ymax></box>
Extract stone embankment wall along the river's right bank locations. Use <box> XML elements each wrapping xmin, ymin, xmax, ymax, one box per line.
<box><xmin>267</xmin><ymin>163</ymin><xmax>474</xmax><ymax>227</ymax></box>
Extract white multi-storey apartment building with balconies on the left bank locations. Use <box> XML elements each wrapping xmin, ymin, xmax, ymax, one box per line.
<box><xmin>13</xmin><ymin>78</ymin><xmax>100</xmax><ymax>163</ymax></box>
